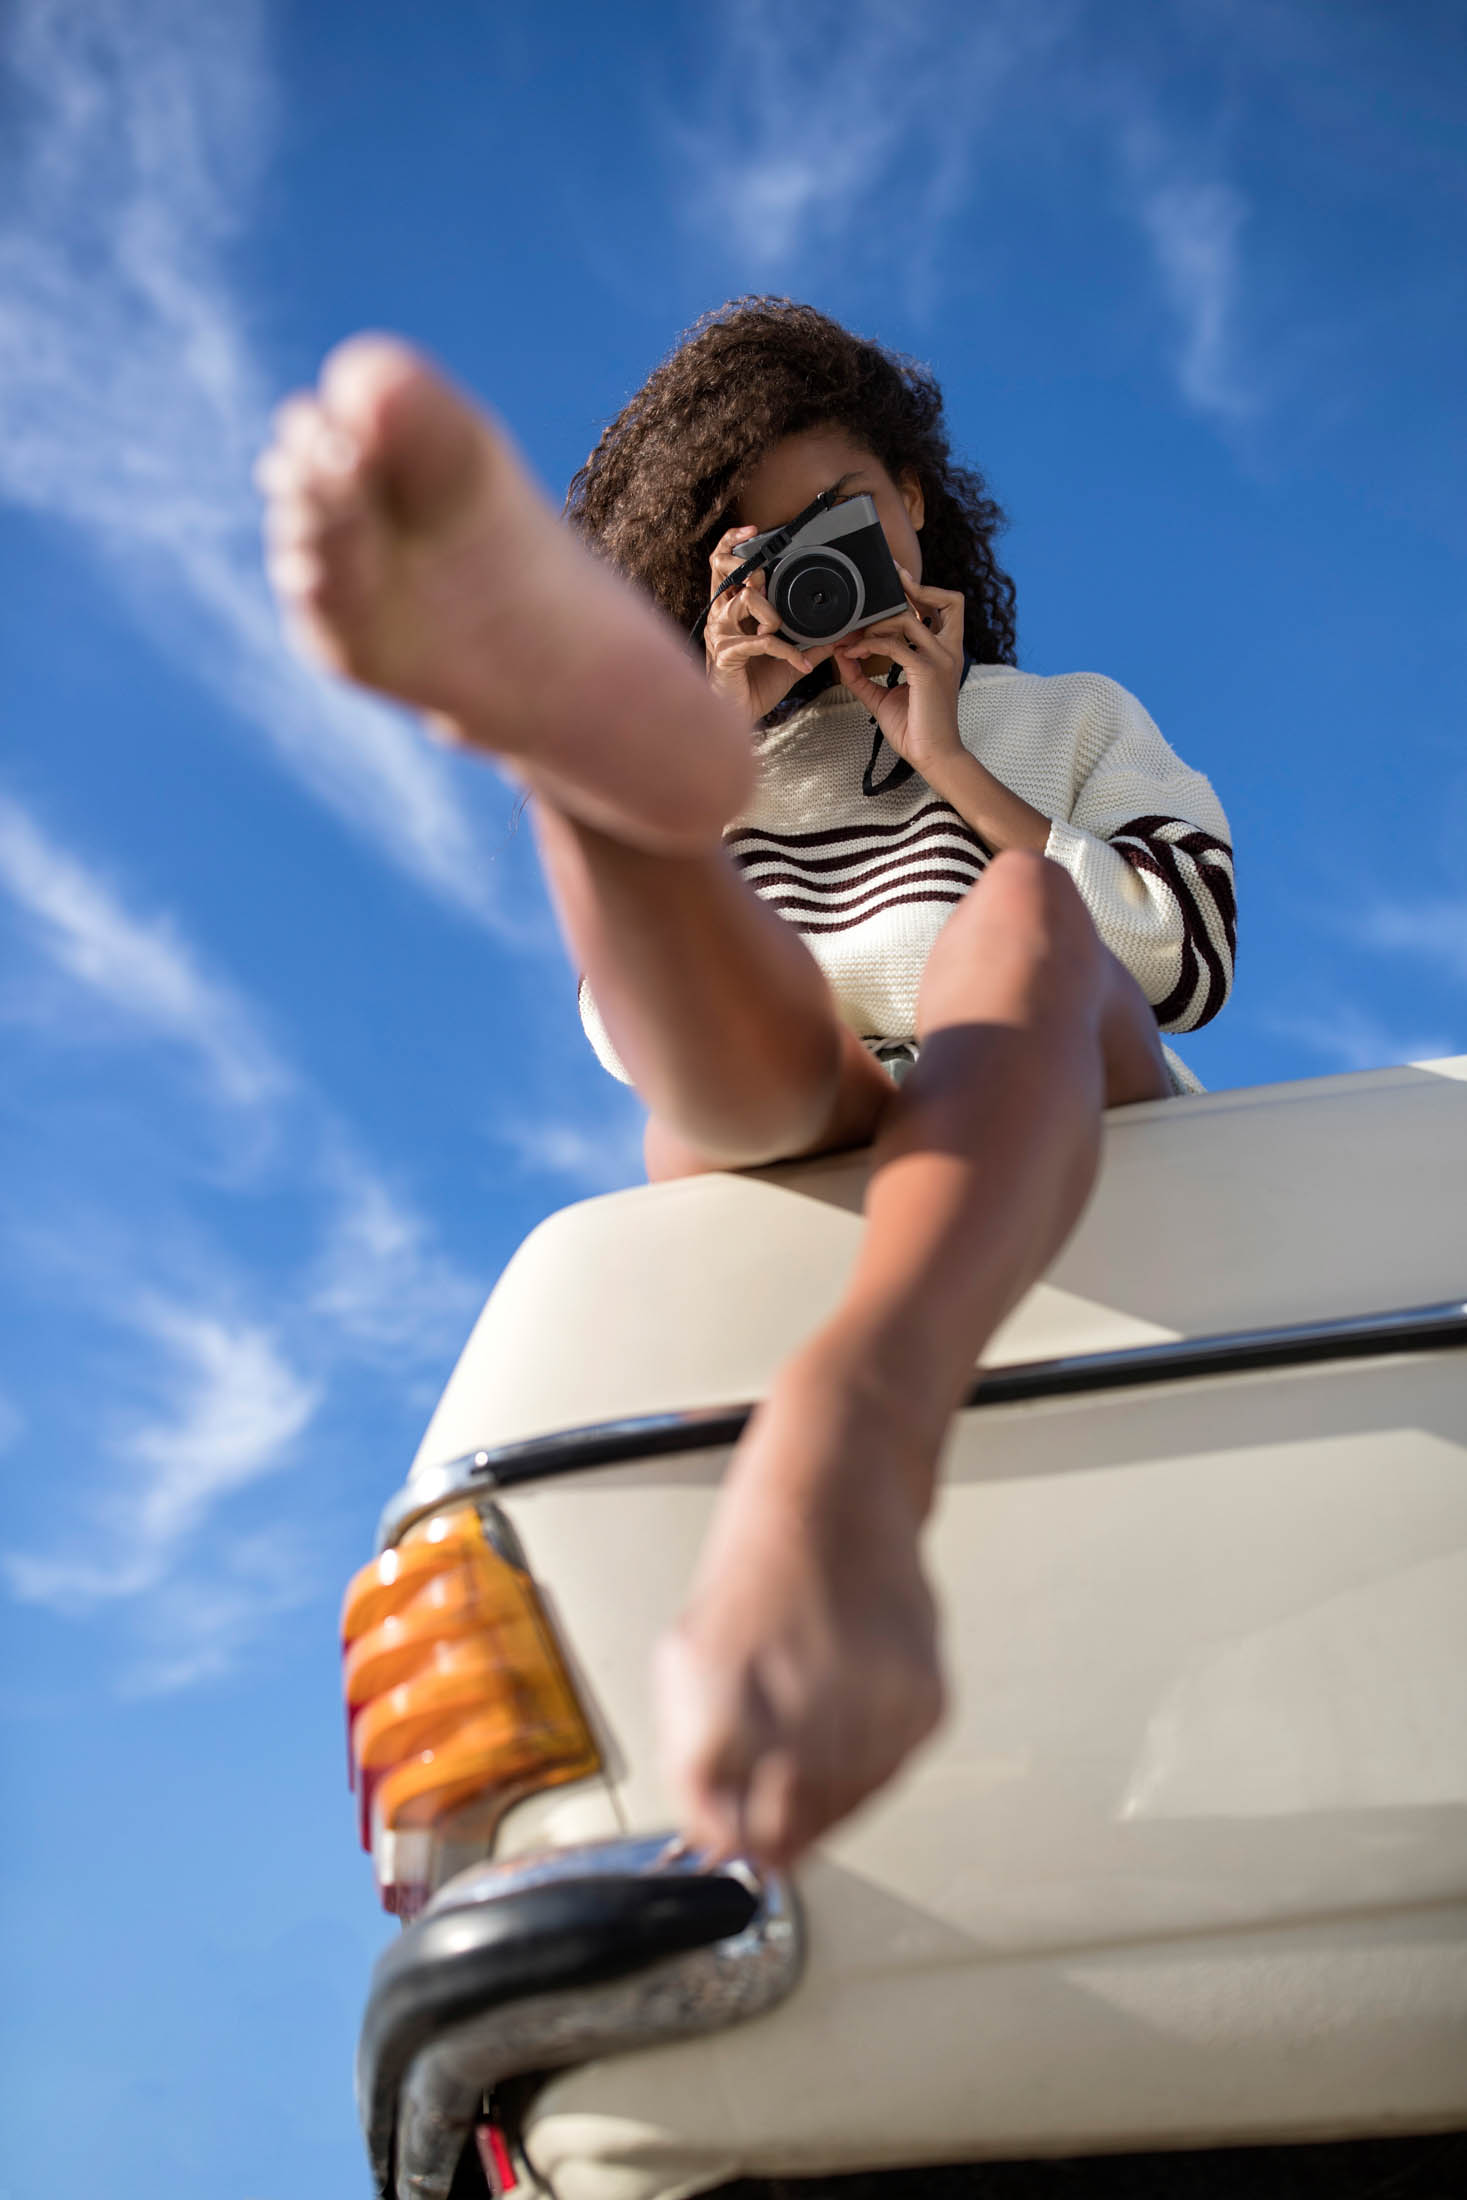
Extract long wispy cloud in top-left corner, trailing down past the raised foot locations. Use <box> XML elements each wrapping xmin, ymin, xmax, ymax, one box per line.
<box><xmin>0</xmin><ymin>0</ymin><xmax>501</xmax><ymax>924</ymax></box>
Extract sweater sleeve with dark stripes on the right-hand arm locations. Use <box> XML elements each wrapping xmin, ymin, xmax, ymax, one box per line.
<box><xmin>1045</xmin><ymin>673</ymin><xmax>1238</xmax><ymax>1032</ymax></box>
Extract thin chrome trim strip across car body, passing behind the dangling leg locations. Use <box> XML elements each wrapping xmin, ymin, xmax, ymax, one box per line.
<box><xmin>376</xmin><ymin>1298</ymin><xmax>1467</xmax><ymax>1551</ymax></box>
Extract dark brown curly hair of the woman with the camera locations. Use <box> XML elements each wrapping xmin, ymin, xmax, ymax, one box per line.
<box><xmin>565</xmin><ymin>297</ymin><xmax>1016</xmax><ymax>678</ymax></box>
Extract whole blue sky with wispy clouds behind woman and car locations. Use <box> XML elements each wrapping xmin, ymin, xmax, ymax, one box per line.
<box><xmin>0</xmin><ymin>0</ymin><xmax>1467</xmax><ymax>2200</ymax></box>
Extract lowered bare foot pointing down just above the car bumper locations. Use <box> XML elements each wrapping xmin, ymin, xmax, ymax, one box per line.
<box><xmin>655</xmin><ymin>1353</ymin><xmax>944</xmax><ymax>1866</ymax></box>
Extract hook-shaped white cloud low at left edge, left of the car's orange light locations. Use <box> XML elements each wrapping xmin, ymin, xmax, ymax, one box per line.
<box><xmin>4</xmin><ymin>1296</ymin><xmax>321</xmax><ymax>1615</ymax></box>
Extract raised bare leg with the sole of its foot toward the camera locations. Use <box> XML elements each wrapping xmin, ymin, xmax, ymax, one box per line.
<box><xmin>260</xmin><ymin>339</ymin><xmax>891</xmax><ymax>1166</ymax></box>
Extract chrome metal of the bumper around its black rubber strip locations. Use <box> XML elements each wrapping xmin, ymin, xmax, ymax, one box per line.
<box><xmin>373</xmin><ymin>1835</ymin><xmax>805</xmax><ymax>2200</ymax></box>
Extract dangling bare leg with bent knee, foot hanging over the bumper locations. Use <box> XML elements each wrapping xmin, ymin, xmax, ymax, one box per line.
<box><xmin>658</xmin><ymin>854</ymin><xmax>1168</xmax><ymax>1863</ymax></box>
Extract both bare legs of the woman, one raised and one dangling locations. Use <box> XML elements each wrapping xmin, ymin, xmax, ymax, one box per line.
<box><xmin>262</xmin><ymin>341</ymin><xmax>1166</xmax><ymax>1859</ymax></box>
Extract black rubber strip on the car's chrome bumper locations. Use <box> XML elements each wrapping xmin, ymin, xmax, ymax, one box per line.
<box><xmin>356</xmin><ymin>1872</ymin><xmax>759</xmax><ymax>2189</ymax></box>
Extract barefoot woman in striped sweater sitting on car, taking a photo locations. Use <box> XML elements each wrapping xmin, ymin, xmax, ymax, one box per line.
<box><xmin>262</xmin><ymin>299</ymin><xmax>1232</xmax><ymax>1863</ymax></box>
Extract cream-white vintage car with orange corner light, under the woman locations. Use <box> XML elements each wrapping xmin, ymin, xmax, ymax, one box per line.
<box><xmin>343</xmin><ymin>1058</ymin><xmax>1467</xmax><ymax>2200</ymax></box>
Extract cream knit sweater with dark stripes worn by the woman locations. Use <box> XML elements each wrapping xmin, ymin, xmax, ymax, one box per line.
<box><xmin>581</xmin><ymin>664</ymin><xmax>1236</xmax><ymax>1089</ymax></box>
